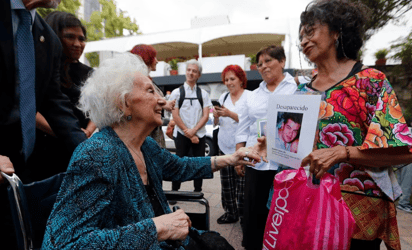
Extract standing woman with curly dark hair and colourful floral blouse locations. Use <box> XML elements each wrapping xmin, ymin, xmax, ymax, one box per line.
<box><xmin>298</xmin><ymin>0</ymin><xmax>412</xmax><ymax>249</ymax></box>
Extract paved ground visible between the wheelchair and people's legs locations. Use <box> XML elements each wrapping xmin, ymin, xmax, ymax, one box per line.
<box><xmin>163</xmin><ymin>172</ymin><xmax>412</xmax><ymax>250</ymax></box>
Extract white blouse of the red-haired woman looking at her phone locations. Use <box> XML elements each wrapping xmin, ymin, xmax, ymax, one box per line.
<box><xmin>217</xmin><ymin>89</ymin><xmax>252</xmax><ymax>155</ymax></box>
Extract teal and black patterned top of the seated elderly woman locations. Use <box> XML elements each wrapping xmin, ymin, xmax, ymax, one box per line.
<box><xmin>42</xmin><ymin>128</ymin><xmax>213</xmax><ymax>250</ymax></box>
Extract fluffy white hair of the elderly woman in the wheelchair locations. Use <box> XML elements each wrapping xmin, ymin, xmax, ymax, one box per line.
<box><xmin>79</xmin><ymin>53</ymin><xmax>149</xmax><ymax>129</ymax></box>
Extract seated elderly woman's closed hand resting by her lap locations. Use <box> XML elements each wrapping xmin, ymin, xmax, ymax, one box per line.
<box><xmin>153</xmin><ymin>209</ymin><xmax>192</xmax><ymax>241</ymax></box>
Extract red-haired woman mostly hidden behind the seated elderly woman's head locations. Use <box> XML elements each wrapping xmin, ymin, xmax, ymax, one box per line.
<box><xmin>130</xmin><ymin>44</ymin><xmax>176</xmax><ymax>148</ymax></box>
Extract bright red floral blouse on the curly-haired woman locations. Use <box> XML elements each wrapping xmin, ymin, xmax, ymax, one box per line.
<box><xmin>298</xmin><ymin>68</ymin><xmax>412</xmax><ymax>200</ymax></box>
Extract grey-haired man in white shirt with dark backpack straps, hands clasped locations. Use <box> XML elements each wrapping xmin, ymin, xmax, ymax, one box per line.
<box><xmin>169</xmin><ymin>59</ymin><xmax>212</xmax><ymax>192</ymax></box>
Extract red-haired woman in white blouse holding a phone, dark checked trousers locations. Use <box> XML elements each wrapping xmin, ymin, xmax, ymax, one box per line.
<box><xmin>213</xmin><ymin>65</ymin><xmax>250</xmax><ymax>224</ymax></box>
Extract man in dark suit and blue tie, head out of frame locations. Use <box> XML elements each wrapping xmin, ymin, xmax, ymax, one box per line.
<box><xmin>0</xmin><ymin>0</ymin><xmax>87</xmax><ymax>246</ymax></box>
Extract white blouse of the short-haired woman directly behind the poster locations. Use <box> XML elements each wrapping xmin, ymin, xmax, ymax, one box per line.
<box><xmin>236</xmin><ymin>72</ymin><xmax>297</xmax><ymax>170</ymax></box>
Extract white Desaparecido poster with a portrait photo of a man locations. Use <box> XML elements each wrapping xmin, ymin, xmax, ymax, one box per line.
<box><xmin>266</xmin><ymin>95</ymin><xmax>321</xmax><ymax>169</ymax></box>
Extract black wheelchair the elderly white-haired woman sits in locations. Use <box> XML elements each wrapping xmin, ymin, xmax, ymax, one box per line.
<box><xmin>0</xmin><ymin>172</ymin><xmax>210</xmax><ymax>250</ymax></box>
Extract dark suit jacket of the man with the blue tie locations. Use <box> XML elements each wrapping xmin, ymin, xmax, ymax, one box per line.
<box><xmin>0</xmin><ymin>0</ymin><xmax>87</xmax><ymax>182</ymax></box>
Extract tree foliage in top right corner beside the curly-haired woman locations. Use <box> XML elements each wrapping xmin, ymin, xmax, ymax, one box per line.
<box><xmin>350</xmin><ymin>0</ymin><xmax>412</xmax><ymax>40</ymax></box>
